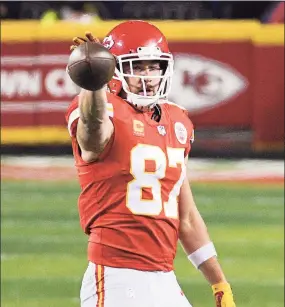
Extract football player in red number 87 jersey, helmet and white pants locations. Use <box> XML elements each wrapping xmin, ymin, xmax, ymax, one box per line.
<box><xmin>66</xmin><ymin>21</ymin><xmax>235</xmax><ymax>307</ymax></box>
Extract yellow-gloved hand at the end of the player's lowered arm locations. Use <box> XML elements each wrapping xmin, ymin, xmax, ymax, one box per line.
<box><xmin>212</xmin><ymin>282</ymin><xmax>236</xmax><ymax>307</ymax></box>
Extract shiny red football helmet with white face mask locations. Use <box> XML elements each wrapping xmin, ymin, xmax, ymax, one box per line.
<box><xmin>102</xmin><ymin>20</ymin><xmax>173</xmax><ymax>106</ymax></box>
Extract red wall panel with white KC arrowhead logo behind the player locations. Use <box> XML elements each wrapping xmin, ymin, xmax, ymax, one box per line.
<box><xmin>170</xmin><ymin>41</ymin><xmax>250</xmax><ymax>128</ymax></box>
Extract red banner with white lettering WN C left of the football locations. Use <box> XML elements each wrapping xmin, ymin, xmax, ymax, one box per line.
<box><xmin>1</xmin><ymin>42</ymin><xmax>75</xmax><ymax>126</ymax></box>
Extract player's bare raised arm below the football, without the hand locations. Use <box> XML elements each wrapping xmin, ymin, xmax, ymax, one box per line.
<box><xmin>76</xmin><ymin>87</ymin><xmax>114</xmax><ymax>162</ymax></box>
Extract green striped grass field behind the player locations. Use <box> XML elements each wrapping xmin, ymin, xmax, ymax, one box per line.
<box><xmin>1</xmin><ymin>181</ymin><xmax>284</xmax><ymax>307</ymax></box>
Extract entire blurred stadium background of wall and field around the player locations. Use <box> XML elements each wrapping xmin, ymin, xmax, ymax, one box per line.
<box><xmin>0</xmin><ymin>1</ymin><xmax>284</xmax><ymax>307</ymax></box>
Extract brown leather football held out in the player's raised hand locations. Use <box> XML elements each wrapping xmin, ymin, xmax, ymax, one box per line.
<box><xmin>67</xmin><ymin>42</ymin><xmax>116</xmax><ymax>91</ymax></box>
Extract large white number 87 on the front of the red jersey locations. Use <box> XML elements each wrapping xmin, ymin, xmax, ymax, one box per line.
<box><xmin>126</xmin><ymin>144</ymin><xmax>186</xmax><ymax>218</ymax></box>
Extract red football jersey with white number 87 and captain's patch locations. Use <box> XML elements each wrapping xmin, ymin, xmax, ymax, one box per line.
<box><xmin>66</xmin><ymin>93</ymin><xmax>193</xmax><ymax>271</ymax></box>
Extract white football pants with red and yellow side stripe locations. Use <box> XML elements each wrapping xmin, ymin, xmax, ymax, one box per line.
<box><xmin>80</xmin><ymin>262</ymin><xmax>191</xmax><ymax>307</ymax></box>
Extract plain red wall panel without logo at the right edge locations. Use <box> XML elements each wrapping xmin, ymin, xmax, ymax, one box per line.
<box><xmin>252</xmin><ymin>45</ymin><xmax>284</xmax><ymax>151</ymax></box>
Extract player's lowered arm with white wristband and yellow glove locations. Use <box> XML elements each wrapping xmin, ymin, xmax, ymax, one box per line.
<box><xmin>179</xmin><ymin>159</ymin><xmax>235</xmax><ymax>307</ymax></box>
